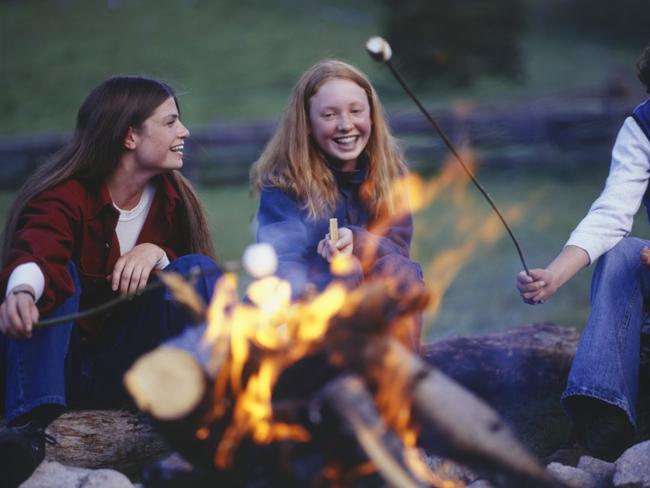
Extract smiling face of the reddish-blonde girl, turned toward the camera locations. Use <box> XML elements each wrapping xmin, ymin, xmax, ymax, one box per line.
<box><xmin>309</xmin><ymin>78</ymin><xmax>372</xmax><ymax>171</ymax></box>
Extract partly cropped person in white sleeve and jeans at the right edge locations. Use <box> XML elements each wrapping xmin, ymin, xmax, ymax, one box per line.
<box><xmin>517</xmin><ymin>47</ymin><xmax>650</xmax><ymax>465</ymax></box>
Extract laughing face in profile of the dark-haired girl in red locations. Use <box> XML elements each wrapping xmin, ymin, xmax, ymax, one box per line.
<box><xmin>126</xmin><ymin>97</ymin><xmax>190</xmax><ymax>174</ymax></box>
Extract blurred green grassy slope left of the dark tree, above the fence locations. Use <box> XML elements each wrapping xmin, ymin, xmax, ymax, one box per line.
<box><xmin>0</xmin><ymin>0</ymin><xmax>376</xmax><ymax>134</ymax></box>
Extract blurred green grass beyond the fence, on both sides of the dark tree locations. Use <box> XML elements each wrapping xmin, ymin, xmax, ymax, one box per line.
<box><xmin>0</xmin><ymin>0</ymin><xmax>642</xmax><ymax>135</ymax></box>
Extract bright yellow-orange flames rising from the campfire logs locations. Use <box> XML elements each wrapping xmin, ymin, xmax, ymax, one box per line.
<box><xmin>197</xmin><ymin>141</ymin><xmax>525</xmax><ymax>488</ymax></box>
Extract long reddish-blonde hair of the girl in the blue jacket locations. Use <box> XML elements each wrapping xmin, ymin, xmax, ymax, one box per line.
<box><xmin>250</xmin><ymin>59</ymin><xmax>406</xmax><ymax>219</ymax></box>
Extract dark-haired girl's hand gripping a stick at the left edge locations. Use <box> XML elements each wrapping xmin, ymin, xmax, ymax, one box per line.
<box><xmin>0</xmin><ymin>285</ymin><xmax>38</xmax><ymax>339</ymax></box>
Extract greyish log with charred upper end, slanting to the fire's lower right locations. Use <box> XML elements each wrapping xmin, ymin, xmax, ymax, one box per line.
<box><xmin>328</xmin><ymin>284</ymin><xmax>559</xmax><ymax>488</ymax></box>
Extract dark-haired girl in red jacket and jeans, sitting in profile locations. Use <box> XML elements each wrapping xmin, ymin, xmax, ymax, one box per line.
<box><xmin>0</xmin><ymin>76</ymin><xmax>218</xmax><ymax>485</ymax></box>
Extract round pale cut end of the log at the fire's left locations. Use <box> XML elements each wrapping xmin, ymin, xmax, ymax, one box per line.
<box><xmin>124</xmin><ymin>347</ymin><xmax>206</xmax><ymax>421</ymax></box>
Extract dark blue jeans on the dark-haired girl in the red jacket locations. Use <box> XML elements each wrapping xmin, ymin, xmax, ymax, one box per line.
<box><xmin>0</xmin><ymin>254</ymin><xmax>221</xmax><ymax>422</ymax></box>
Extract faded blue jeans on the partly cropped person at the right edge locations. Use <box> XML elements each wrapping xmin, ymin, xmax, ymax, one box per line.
<box><xmin>562</xmin><ymin>237</ymin><xmax>650</xmax><ymax>426</ymax></box>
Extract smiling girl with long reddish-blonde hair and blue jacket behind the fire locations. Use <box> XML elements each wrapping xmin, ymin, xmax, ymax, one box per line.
<box><xmin>251</xmin><ymin>60</ymin><xmax>423</xmax><ymax>349</ymax></box>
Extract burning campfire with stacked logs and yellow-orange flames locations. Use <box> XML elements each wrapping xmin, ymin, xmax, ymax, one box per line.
<box><xmin>125</xmin><ymin>231</ymin><xmax>558</xmax><ymax>488</ymax></box>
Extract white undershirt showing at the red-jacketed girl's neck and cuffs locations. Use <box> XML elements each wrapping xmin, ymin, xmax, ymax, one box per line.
<box><xmin>6</xmin><ymin>183</ymin><xmax>169</xmax><ymax>301</ymax></box>
